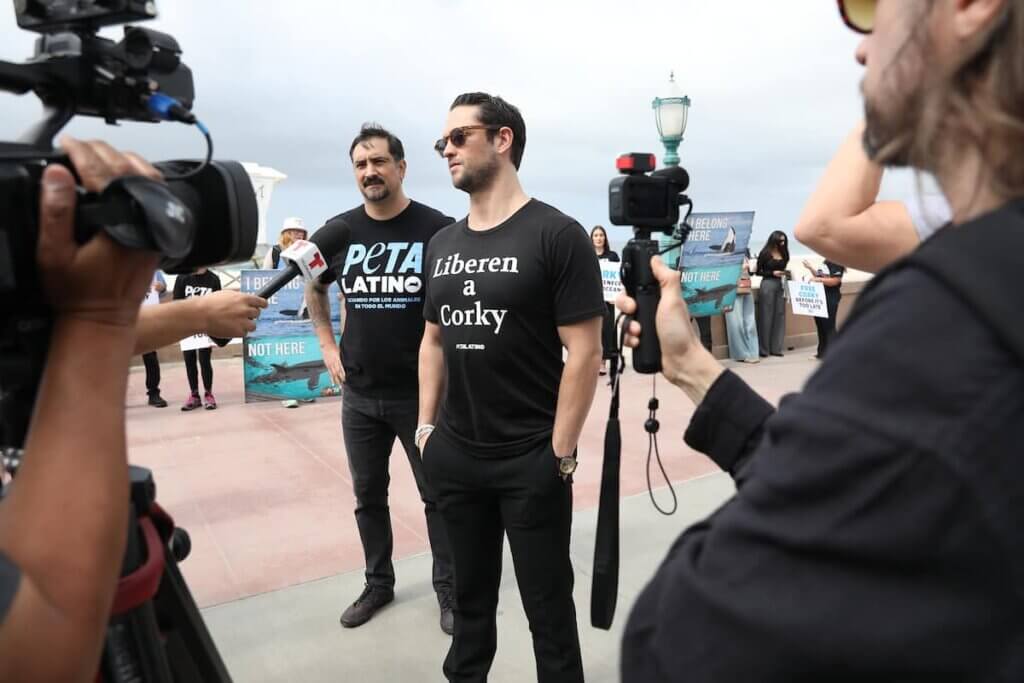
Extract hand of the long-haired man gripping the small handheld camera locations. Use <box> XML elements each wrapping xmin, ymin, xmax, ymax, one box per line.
<box><xmin>615</xmin><ymin>256</ymin><xmax>722</xmax><ymax>402</ymax></box>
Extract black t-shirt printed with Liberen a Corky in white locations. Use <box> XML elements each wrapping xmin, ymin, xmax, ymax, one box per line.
<box><xmin>424</xmin><ymin>200</ymin><xmax>604</xmax><ymax>457</ymax></box>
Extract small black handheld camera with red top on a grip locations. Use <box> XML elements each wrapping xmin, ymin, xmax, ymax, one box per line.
<box><xmin>608</xmin><ymin>154</ymin><xmax>693</xmax><ymax>375</ymax></box>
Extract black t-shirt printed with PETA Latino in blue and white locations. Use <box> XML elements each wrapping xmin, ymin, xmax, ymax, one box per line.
<box><xmin>321</xmin><ymin>202</ymin><xmax>454</xmax><ymax>399</ymax></box>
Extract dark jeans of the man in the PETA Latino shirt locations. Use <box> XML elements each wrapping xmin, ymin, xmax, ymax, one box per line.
<box><xmin>341</xmin><ymin>387</ymin><xmax>453</xmax><ymax>593</ymax></box>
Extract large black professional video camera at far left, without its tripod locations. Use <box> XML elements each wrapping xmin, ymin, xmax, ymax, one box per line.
<box><xmin>0</xmin><ymin>0</ymin><xmax>258</xmax><ymax>454</ymax></box>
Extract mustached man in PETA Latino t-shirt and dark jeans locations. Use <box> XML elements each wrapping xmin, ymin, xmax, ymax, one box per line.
<box><xmin>306</xmin><ymin>124</ymin><xmax>454</xmax><ymax>634</ymax></box>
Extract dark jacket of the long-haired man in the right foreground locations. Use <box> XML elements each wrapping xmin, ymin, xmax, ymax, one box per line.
<box><xmin>622</xmin><ymin>202</ymin><xmax>1024</xmax><ymax>683</ymax></box>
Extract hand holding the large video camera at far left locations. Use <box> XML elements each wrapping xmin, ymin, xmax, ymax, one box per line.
<box><xmin>37</xmin><ymin>137</ymin><xmax>161</xmax><ymax>327</ymax></box>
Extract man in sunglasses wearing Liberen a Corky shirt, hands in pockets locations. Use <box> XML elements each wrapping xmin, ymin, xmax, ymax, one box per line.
<box><xmin>416</xmin><ymin>93</ymin><xmax>605</xmax><ymax>682</ymax></box>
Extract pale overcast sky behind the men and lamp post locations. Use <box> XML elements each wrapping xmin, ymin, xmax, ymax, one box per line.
<box><xmin>0</xmin><ymin>0</ymin><xmax>929</xmax><ymax>252</ymax></box>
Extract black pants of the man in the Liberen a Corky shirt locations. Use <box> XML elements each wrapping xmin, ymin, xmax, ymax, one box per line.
<box><xmin>423</xmin><ymin>429</ymin><xmax>584</xmax><ymax>683</ymax></box>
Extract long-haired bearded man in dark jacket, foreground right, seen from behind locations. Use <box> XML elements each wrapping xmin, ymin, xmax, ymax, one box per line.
<box><xmin>620</xmin><ymin>0</ymin><xmax>1024</xmax><ymax>683</ymax></box>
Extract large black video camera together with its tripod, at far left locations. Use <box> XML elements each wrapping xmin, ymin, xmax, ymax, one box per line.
<box><xmin>0</xmin><ymin>0</ymin><xmax>249</xmax><ymax>683</ymax></box>
